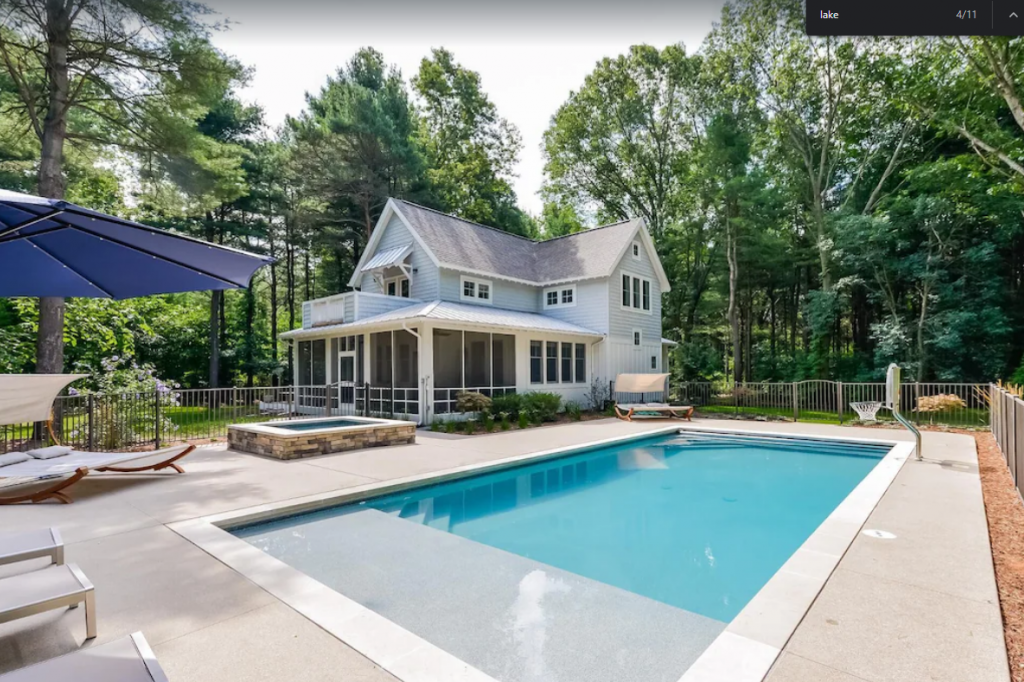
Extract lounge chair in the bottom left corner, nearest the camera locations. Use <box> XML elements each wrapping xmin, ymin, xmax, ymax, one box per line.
<box><xmin>0</xmin><ymin>632</ymin><xmax>168</xmax><ymax>682</ymax></box>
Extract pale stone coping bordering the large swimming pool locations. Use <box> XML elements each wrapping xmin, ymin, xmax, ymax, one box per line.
<box><xmin>168</xmin><ymin>424</ymin><xmax>913</xmax><ymax>682</ymax></box>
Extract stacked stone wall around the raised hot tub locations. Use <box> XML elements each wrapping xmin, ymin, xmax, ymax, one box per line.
<box><xmin>227</xmin><ymin>422</ymin><xmax>416</xmax><ymax>460</ymax></box>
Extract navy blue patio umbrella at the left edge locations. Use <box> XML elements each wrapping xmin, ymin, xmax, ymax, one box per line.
<box><xmin>0</xmin><ymin>189</ymin><xmax>273</xmax><ymax>299</ymax></box>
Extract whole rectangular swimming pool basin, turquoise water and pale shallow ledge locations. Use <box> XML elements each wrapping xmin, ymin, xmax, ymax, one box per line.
<box><xmin>231</xmin><ymin>432</ymin><xmax>891</xmax><ymax>682</ymax></box>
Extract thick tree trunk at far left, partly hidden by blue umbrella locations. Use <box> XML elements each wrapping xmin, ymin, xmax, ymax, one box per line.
<box><xmin>36</xmin><ymin>0</ymin><xmax>72</xmax><ymax>374</ymax></box>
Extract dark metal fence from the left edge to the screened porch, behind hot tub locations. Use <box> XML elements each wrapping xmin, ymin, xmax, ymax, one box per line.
<box><xmin>0</xmin><ymin>384</ymin><xmax>420</xmax><ymax>453</ymax></box>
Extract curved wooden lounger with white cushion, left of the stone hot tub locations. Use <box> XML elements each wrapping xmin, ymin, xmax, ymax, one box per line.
<box><xmin>0</xmin><ymin>444</ymin><xmax>196</xmax><ymax>505</ymax></box>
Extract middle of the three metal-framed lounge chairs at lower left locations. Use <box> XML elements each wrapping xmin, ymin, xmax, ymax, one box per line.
<box><xmin>0</xmin><ymin>563</ymin><xmax>96</xmax><ymax>638</ymax></box>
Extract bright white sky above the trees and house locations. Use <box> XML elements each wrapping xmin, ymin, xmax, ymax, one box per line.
<box><xmin>206</xmin><ymin>0</ymin><xmax>724</xmax><ymax>215</ymax></box>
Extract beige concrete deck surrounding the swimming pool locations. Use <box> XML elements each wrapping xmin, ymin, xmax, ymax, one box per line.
<box><xmin>0</xmin><ymin>420</ymin><xmax>1009</xmax><ymax>682</ymax></box>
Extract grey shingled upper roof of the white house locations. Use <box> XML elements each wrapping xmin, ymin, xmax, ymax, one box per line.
<box><xmin>394</xmin><ymin>200</ymin><xmax>639</xmax><ymax>285</ymax></box>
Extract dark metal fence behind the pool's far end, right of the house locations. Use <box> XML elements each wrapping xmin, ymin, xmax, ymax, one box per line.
<box><xmin>672</xmin><ymin>380</ymin><xmax>989</xmax><ymax>428</ymax></box>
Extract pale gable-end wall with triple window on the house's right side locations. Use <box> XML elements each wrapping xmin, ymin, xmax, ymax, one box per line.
<box><xmin>605</xmin><ymin>236</ymin><xmax>664</xmax><ymax>379</ymax></box>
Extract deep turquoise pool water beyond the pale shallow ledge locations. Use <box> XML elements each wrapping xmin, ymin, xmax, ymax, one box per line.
<box><xmin>236</xmin><ymin>435</ymin><xmax>889</xmax><ymax>622</ymax></box>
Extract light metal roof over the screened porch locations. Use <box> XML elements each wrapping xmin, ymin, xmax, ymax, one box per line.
<box><xmin>281</xmin><ymin>301</ymin><xmax>604</xmax><ymax>339</ymax></box>
